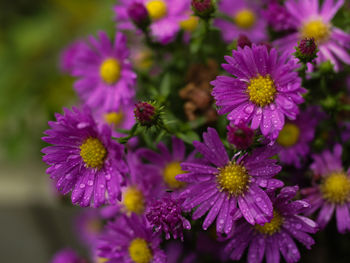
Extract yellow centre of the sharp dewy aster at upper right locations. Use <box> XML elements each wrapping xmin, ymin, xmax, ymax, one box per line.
<box><xmin>247</xmin><ymin>75</ymin><xmax>277</xmax><ymax>107</ymax></box>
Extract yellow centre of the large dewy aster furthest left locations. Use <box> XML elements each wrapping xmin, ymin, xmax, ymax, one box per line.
<box><xmin>80</xmin><ymin>137</ymin><xmax>107</xmax><ymax>168</ymax></box>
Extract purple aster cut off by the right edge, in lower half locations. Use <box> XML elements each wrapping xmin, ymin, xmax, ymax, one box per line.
<box><xmin>302</xmin><ymin>144</ymin><xmax>350</xmax><ymax>233</ymax></box>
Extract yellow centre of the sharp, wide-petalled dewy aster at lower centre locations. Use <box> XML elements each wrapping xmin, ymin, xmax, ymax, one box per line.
<box><xmin>216</xmin><ymin>163</ymin><xmax>250</xmax><ymax>196</ymax></box>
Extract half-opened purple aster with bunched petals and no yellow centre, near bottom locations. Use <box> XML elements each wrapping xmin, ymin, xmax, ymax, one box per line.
<box><xmin>146</xmin><ymin>195</ymin><xmax>191</xmax><ymax>241</ymax></box>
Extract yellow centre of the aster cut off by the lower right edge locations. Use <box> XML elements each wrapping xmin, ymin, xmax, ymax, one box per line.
<box><xmin>320</xmin><ymin>172</ymin><xmax>350</xmax><ymax>204</ymax></box>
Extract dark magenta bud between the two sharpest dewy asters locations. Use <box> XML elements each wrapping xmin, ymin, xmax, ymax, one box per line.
<box><xmin>227</xmin><ymin>123</ymin><xmax>254</xmax><ymax>149</ymax></box>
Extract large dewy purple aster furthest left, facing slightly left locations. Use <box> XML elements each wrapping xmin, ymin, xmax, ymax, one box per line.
<box><xmin>42</xmin><ymin>107</ymin><xmax>125</xmax><ymax>207</ymax></box>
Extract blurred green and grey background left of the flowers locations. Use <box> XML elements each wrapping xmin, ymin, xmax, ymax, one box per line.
<box><xmin>0</xmin><ymin>0</ymin><xmax>116</xmax><ymax>263</ymax></box>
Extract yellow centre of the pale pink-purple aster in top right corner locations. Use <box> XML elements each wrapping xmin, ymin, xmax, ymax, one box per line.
<box><xmin>300</xmin><ymin>19</ymin><xmax>330</xmax><ymax>43</ymax></box>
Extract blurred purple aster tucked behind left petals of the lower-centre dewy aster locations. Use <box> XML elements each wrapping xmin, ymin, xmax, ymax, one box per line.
<box><xmin>137</xmin><ymin>137</ymin><xmax>195</xmax><ymax>194</ymax></box>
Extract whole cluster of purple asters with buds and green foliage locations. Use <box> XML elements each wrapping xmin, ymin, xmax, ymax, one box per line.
<box><xmin>42</xmin><ymin>0</ymin><xmax>350</xmax><ymax>263</ymax></box>
